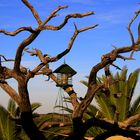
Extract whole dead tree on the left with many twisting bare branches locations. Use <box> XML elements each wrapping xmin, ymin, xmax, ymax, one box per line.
<box><xmin>0</xmin><ymin>0</ymin><xmax>97</xmax><ymax>140</ymax></box>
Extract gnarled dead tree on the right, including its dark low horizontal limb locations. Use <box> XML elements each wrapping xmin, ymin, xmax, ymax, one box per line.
<box><xmin>65</xmin><ymin>10</ymin><xmax>140</xmax><ymax>140</ymax></box>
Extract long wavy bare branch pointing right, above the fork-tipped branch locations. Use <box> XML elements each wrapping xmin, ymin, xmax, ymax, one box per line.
<box><xmin>44</xmin><ymin>12</ymin><xmax>94</xmax><ymax>30</ymax></box>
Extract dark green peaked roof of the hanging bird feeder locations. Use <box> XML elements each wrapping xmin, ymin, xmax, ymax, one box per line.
<box><xmin>54</xmin><ymin>64</ymin><xmax>77</xmax><ymax>76</ymax></box>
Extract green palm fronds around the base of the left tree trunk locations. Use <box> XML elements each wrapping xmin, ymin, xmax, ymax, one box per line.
<box><xmin>0</xmin><ymin>99</ymin><xmax>50</xmax><ymax>140</ymax></box>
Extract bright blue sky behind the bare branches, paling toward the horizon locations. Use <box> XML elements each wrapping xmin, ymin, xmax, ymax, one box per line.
<box><xmin>0</xmin><ymin>0</ymin><xmax>140</xmax><ymax>111</ymax></box>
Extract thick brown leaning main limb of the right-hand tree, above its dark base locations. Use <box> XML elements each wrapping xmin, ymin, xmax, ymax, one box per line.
<box><xmin>73</xmin><ymin>10</ymin><xmax>140</xmax><ymax>118</ymax></box>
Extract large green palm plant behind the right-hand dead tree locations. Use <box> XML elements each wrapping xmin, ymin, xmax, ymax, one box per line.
<box><xmin>81</xmin><ymin>67</ymin><xmax>140</xmax><ymax>136</ymax></box>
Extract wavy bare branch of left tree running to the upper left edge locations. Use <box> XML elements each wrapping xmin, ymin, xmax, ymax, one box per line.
<box><xmin>0</xmin><ymin>27</ymin><xmax>35</xmax><ymax>36</ymax></box>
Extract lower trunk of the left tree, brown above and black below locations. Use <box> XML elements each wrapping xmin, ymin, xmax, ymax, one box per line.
<box><xmin>18</xmin><ymin>79</ymin><xmax>46</xmax><ymax>140</ymax></box>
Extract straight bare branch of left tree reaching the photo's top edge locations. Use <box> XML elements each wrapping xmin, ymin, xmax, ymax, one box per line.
<box><xmin>22</xmin><ymin>0</ymin><xmax>42</xmax><ymax>25</ymax></box>
